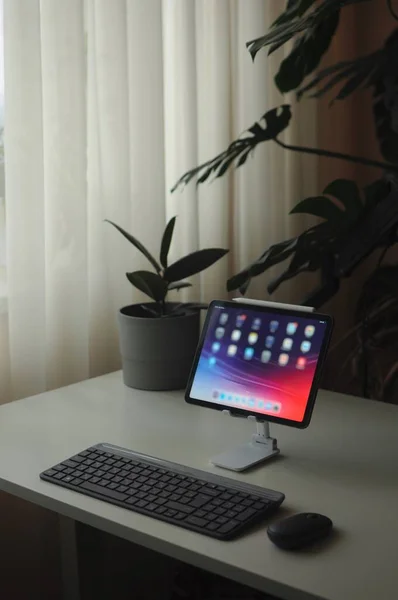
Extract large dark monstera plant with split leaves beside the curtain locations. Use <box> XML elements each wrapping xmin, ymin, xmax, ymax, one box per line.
<box><xmin>174</xmin><ymin>0</ymin><xmax>398</xmax><ymax>399</ymax></box>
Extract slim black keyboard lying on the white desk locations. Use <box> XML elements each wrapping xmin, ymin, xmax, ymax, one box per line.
<box><xmin>40</xmin><ymin>444</ymin><xmax>285</xmax><ymax>540</ymax></box>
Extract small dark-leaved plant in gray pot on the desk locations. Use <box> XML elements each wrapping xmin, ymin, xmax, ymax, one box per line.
<box><xmin>107</xmin><ymin>217</ymin><xmax>228</xmax><ymax>390</ymax></box>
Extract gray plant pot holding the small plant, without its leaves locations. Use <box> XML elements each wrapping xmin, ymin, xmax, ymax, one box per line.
<box><xmin>118</xmin><ymin>303</ymin><xmax>200</xmax><ymax>390</ymax></box>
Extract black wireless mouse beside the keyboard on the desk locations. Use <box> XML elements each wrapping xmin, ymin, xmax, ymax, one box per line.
<box><xmin>267</xmin><ymin>513</ymin><xmax>333</xmax><ymax>550</ymax></box>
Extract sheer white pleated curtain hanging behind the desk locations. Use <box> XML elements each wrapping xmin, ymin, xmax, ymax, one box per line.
<box><xmin>0</xmin><ymin>0</ymin><xmax>316</xmax><ymax>401</ymax></box>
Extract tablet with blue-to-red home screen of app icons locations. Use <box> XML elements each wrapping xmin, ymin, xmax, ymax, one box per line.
<box><xmin>185</xmin><ymin>300</ymin><xmax>333</xmax><ymax>428</ymax></box>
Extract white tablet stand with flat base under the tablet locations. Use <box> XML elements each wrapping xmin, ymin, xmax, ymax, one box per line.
<box><xmin>210</xmin><ymin>410</ymin><xmax>280</xmax><ymax>471</ymax></box>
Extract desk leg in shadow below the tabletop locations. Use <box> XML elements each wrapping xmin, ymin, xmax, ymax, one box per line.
<box><xmin>59</xmin><ymin>515</ymin><xmax>80</xmax><ymax>600</ymax></box>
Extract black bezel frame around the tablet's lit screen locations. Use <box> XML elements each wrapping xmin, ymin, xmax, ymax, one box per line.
<box><xmin>185</xmin><ymin>300</ymin><xmax>333</xmax><ymax>429</ymax></box>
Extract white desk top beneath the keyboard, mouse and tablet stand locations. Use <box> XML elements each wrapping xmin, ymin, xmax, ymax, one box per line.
<box><xmin>0</xmin><ymin>373</ymin><xmax>398</xmax><ymax>600</ymax></box>
